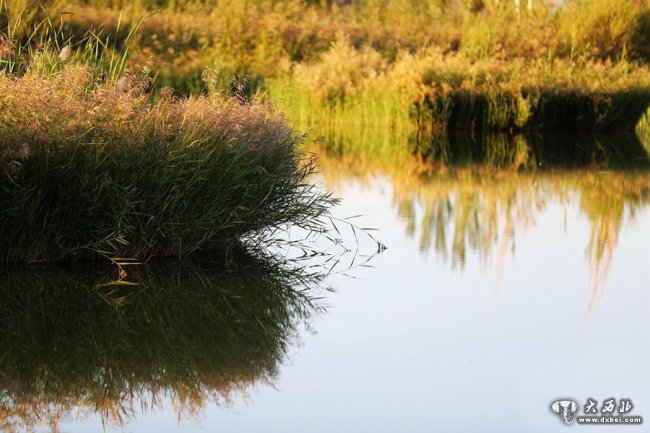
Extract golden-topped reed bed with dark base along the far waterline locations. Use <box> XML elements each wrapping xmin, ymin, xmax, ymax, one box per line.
<box><xmin>268</xmin><ymin>42</ymin><xmax>650</xmax><ymax>133</ymax></box>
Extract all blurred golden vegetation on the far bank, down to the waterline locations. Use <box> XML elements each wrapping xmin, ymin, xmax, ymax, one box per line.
<box><xmin>5</xmin><ymin>0</ymin><xmax>650</xmax><ymax>131</ymax></box>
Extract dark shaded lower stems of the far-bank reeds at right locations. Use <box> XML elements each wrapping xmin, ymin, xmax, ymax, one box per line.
<box><xmin>417</xmin><ymin>89</ymin><xmax>650</xmax><ymax>133</ymax></box>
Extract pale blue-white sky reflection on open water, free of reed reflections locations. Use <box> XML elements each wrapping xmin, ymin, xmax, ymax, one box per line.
<box><xmin>201</xmin><ymin>168</ymin><xmax>650</xmax><ymax>433</ymax></box>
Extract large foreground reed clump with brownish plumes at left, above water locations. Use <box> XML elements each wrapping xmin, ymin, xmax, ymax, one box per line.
<box><xmin>0</xmin><ymin>60</ymin><xmax>332</xmax><ymax>263</ymax></box>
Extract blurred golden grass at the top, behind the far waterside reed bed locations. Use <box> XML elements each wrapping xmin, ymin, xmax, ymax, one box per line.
<box><xmin>5</xmin><ymin>0</ymin><xmax>650</xmax><ymax>93</ymax></box>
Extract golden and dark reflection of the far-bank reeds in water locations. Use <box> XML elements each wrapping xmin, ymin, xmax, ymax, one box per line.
<box><xmin>315</xmin><ymin>126</ymin><xmax>650</xmax><ymax>311</ymax></box>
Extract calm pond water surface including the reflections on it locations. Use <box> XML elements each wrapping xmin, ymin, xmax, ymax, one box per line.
<box><xmin>0</xmin><ymin>133</ymin><xmax>650</xmax><ymax>432</ymax></box>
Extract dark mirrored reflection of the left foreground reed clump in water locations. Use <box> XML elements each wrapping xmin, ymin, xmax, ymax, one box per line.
<box><xmin>0</xmin><ymin>250</ymin><xmax>321</xmax><ymax>432</ymax></box>
